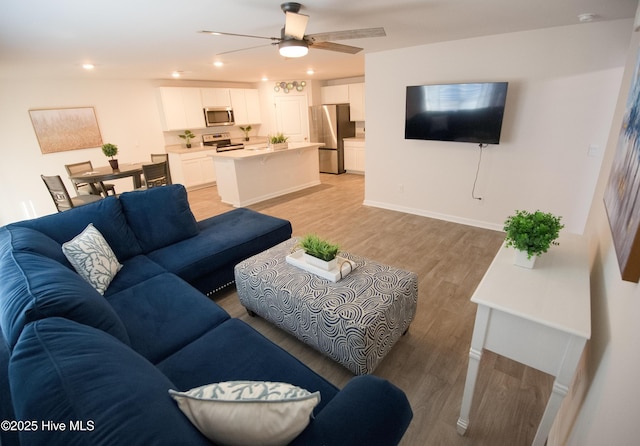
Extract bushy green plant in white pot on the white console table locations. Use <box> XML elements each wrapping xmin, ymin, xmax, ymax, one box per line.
<box><xmin>504</xmin><ymin>210</ymin><xmax>564</xmax><ymax>268</ymax></box>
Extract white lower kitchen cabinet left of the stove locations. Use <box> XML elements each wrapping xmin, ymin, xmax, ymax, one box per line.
<box><xmin>169</xmin><ymin>150</ymin><xmax>216</xmax><ymax>190</ymax></box>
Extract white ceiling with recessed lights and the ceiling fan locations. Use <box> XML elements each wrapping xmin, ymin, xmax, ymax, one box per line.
<box><xmin>0</xmin><ymin>0</ymin><xmax>638</xmax><ymax>82</ymax></box>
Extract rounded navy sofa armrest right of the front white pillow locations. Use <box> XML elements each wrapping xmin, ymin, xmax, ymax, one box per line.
<box><xmin>291</xmin><ymin>375</ymin><xmax>413</xmax><ymax>446</ymax></box>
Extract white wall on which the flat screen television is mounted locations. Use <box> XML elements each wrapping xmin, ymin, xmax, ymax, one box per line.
<box><xmin>365</xmin><ymin>20</ymin><xmax>631</xmax><ymax>233</ymax></box>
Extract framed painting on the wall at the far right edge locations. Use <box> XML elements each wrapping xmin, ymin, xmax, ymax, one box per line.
<box><xmin>604</xmin><ymin>47</ymin><xmax>640</xmax><ymax>283</ymax></box>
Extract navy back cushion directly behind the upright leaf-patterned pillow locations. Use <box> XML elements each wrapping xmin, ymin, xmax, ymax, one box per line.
<box><xmin>9</xmin><ymin>197</ymin><xmax>142</xmax><ymax>262</ymax></box>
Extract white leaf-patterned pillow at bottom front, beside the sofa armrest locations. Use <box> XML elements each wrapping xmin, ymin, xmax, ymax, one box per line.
<box><xmin>169</xmin><ymin>381</ymin><xmax>320</xmax><ymax>446</ymax></box>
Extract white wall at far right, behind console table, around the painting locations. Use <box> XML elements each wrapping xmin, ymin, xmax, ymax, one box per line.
<box><xmin>549</xmin><ymin>18</ymin><xmax>640</xmax><ymax>446</ymax></box>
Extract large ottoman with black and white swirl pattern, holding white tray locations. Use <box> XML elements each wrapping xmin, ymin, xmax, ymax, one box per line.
<box><xmin>235</xmin><ymin>238</ymin><xmax>418</xmax><ymax>375</ymax></box>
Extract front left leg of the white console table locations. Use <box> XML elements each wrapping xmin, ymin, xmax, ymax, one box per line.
<box><xmin>456</xmin><ymin>306</ymin><xmax>491</xmax><ymax>435</ymax></box>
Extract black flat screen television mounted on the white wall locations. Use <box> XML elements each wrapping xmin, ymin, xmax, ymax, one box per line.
<box><xmin>404</xmin><ymin>82</ymin><xmax>508</xmax><ymax>144</ymax></box>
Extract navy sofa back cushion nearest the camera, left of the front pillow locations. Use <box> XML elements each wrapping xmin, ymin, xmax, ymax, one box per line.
<box><xmin>9</xmin><ymin>318</ymin><xmax>210</xmax><ymax>446</ymax></box>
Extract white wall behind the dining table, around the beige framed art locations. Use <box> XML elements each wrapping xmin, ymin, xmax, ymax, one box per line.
<box><xmin>0</xmin><ymin>80</ymin><xmax>164</xmax><ymax>224</ymax></box>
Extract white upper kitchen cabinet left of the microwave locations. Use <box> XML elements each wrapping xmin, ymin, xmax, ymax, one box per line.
<box><xmin>159</xmin><ymin>87</ymin><xmax>206</xmax><ymax>131</ymax></box>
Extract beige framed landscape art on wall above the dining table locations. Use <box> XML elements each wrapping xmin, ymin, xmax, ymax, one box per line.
<box><xmin>29</xmin><ymin>107</ymin><xmax>102</xmax><ymax>154</ymax></box>
